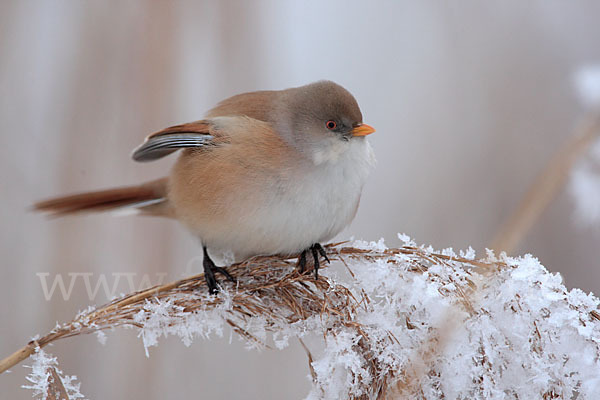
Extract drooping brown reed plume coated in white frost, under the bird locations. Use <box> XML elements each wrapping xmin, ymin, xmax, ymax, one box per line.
<box><xmin>22</xmin><ymin>235</ymin><xmax>600</xmax><ymax>400</ymax></box>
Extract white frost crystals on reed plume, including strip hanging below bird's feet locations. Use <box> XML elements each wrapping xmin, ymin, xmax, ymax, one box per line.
<box><xmin>123</xmin><ymin>237</ymin><xmax>600</xmax><ymax>399</ymax></box>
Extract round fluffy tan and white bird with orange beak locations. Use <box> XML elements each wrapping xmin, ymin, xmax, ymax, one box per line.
<box><xmin>34</xmin><ymin>81</ymin><xmax>375</xmax><ymax>294</ymax></box>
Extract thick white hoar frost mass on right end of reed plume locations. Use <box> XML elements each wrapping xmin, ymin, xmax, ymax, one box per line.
<box><xmin>309</xmin><ymin>242</ymin><xmax>600</xmax><ymax>399</ymax></box>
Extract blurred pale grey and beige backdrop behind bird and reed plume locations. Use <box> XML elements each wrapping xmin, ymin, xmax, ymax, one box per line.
<box><xmin>0</xmin><ymin>0</ymin><xmax>600</xmax><ymax>399</ymax></box>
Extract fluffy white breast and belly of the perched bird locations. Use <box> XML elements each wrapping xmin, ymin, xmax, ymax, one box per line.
<box><xmin>205</xmin><ymin>139</ymin><xmax>375</xmax><ymax>260</ymax></box>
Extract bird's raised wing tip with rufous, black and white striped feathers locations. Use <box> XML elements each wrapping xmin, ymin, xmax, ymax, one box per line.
<box><xmin>131</xmin><ymin>120</ymin><xmax>215</xmax><ymax>162</ymax></box>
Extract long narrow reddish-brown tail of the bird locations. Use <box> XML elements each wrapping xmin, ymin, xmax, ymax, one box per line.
<box><xmin>33</xmin><ymin>178</ymin><xmax>168</xmax><ymax>216</ymax></box>
